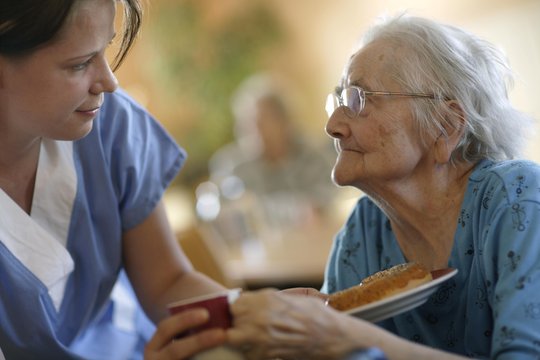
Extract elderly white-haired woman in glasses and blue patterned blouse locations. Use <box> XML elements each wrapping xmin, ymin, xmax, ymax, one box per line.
<box><xmin>228</xmin><ymin>16</ymin><xmax>540</xmax><ymax>359</ymax></box>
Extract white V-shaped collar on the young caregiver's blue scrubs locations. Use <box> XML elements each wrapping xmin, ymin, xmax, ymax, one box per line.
<box><xmin>0</xmin><ymin>139</ymin><xmax>77</xmax><ymax>311</ymax></box>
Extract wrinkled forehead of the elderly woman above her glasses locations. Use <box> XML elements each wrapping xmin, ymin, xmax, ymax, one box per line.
<box><xmin>340</xmin><ymin>40</ymin><xmax>401</xmax><ymax>90</ymax></box>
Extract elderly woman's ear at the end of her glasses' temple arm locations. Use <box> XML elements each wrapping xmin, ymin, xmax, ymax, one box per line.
<box><xmin>433</xmin><ymin>100</ymin><xmax>467</xmax><ymax>164</ymax></box>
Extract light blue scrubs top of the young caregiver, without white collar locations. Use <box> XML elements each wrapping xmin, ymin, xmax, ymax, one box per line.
<box><xmin>0</xmin><ymin>90</ymin><xmax>185</xmax><ymax>360</ymax></box>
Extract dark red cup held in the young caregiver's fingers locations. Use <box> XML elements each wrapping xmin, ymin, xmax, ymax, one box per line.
<box><xmin>167</xmin><ymin>289</ymin><xmax>241</xmax><ymax>338</ymax></box>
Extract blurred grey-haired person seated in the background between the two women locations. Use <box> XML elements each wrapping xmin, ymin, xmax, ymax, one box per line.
<box><xmin>209</xmin><ymin>73</ymin><xmax>337</xmax><ymax>231</ymax></box>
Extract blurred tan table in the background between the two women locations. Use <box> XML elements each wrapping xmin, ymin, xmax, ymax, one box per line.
<box><xmin>201</xmin><ymin>211</ymin><xmax>340</xmax><ymax>289</ymax></box>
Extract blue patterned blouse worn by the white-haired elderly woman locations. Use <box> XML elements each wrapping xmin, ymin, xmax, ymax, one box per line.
<box><xmin>322</xmin><ymin>160</ymin><xmax>540</xmax><ymax>359</ymax></box>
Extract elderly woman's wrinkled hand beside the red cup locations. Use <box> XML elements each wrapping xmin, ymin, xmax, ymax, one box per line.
<box><xmin>227</xmin><ymin>290</ymin><xmax>364</xmax><ymax>360</ymax></box>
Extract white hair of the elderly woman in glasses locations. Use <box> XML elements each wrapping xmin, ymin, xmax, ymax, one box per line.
<box><xmin>354</xmin><ymin>15</ymin><xmax>533</xmax><ymax>162</ymax></box>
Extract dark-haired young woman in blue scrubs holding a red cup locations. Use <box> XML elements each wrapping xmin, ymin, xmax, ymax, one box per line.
<box><xmin>0</xmin><ymin>0</ymin><xmax>231</xmax><ymax>360</ymax></box>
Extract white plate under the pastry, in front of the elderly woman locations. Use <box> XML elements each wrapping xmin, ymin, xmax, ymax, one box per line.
<box><xmin>344</xmin><ymin>268</ymin><xmax>457</xmax><ymax>322</ymax></box>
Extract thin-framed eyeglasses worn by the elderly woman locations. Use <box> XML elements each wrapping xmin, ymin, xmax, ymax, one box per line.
<box><xmin>325</xmin><ymin>86</ymin><xmax>441</xmax><ymax>118</ymax></box>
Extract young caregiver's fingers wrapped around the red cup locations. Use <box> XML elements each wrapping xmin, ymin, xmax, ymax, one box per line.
<box><xmin>144</xmin><ymin>309</ymin><xmax>226</xmax><ymax>360</ymax></box>
